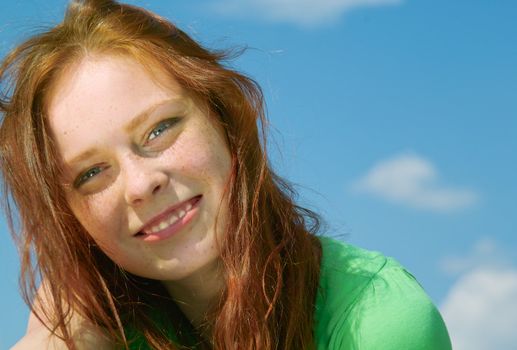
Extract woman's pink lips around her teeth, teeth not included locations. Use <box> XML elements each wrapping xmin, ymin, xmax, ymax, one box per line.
<box><xmin>133</xmin><ymin>195</ymin><xmax>202</xmax><ymax>242</ymax></box>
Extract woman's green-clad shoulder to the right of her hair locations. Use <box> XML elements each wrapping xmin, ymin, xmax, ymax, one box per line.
<box><xmin>315</xmin><ymin>237</ymin><xmax>451</xmax><ymax>350</ymax></box>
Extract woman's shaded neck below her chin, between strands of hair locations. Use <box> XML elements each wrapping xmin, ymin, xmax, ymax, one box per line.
<box><xmin>163</xmin><ymin>259</ymin><xmax>225</xmax><ymax>339</ymax></box>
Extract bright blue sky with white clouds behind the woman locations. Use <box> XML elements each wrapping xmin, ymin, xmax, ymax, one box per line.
<box><xmin>0</xmin><ymin>0</ymin><xmax>517</xmax><ymax>350</ymax></box>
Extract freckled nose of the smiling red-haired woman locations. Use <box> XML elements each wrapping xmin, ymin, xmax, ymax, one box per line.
<box><xmin>121</xmin><ymin>154</ymin><xmax>169</xmax><ymax>206</ymax></box>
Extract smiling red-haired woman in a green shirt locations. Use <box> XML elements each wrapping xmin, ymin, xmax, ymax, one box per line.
<box><xmin>0</xmin><ymin>0</ymin><xmax>450</xmax><ymax>350</ymax></box>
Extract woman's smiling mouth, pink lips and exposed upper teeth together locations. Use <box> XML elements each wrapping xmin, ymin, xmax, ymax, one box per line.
<box><xmin>134</xmin><ymin>195</ymin><xmax>202</xmax><ymax>240</ymax></box>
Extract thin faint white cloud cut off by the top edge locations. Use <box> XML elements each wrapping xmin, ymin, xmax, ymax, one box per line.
<box><xmin>208</xmin><ymin>0</ymin><xmax>402</xmax><ymax>26</ymax></box>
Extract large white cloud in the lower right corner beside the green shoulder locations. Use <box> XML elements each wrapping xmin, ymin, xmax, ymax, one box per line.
<box><xmin>440</xmin><ymin>239</ymin><xmax>517</xmax><ymax>350</ymax></box>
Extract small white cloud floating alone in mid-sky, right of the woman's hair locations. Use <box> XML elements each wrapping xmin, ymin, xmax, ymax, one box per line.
<box><xmin>352</xmin><ymin>153</ymin><xmax>478</xmax><ymax>212</ymax></box>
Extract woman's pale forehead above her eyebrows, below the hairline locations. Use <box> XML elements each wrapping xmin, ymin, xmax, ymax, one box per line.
<box><xmin>47</xmin><ymin>55</ymin><xmax>184</xmax><ymax>122</ymax></box>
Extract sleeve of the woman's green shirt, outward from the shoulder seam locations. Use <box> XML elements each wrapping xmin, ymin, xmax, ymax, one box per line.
<box><xmin>329</xmin><ymin>264</ymin><xmax>452</xmax><ymax>350</ymax></box>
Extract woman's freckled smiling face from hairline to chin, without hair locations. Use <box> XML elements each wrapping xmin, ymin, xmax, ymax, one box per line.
<box><xmin>48</xmin><ymin>56</ymin><xmax>231</xmax><ymax>280</ymax></box>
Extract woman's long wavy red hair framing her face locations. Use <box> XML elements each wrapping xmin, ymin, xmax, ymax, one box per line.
<box><xmin>0</xmin><ymin>0</ymin><xmax>321</xmax><ymax>349</ymax></box>
